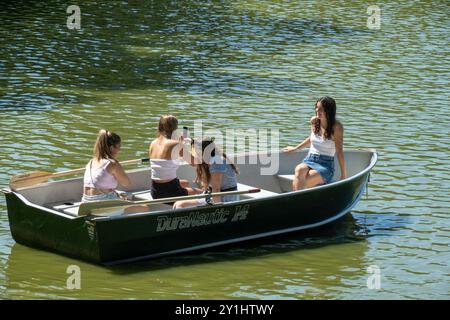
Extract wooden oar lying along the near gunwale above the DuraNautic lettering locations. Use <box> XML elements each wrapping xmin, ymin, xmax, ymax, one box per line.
<box><xmin>78</xmin><ymin>189</ymin><xmax>261</xmax><ymax>216</ymax></box>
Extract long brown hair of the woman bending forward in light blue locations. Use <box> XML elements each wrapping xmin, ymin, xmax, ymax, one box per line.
<box><xmin>195</xmin><ymin>137</ymin><xmax>239</xmax><ymax>188</ymax></box>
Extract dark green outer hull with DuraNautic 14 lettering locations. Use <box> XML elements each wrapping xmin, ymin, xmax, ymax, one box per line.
<box><xmin>6</xmin><ymin>170</ymin><xmax>370</xmax><ymax>264</ymax></box>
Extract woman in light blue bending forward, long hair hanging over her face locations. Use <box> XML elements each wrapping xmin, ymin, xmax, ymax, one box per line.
<box><xmin>173</xmin><ymin>137</ymin><xmax>239</xmax><ymax>209</ymax></box>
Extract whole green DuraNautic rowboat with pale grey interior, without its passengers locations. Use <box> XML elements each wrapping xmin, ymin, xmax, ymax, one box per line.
<box><xmin>2</xmin><ymin>150</ymin><xmax>377</xmax><ymax>264</ymax></box>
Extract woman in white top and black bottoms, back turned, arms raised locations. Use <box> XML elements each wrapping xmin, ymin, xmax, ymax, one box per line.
<box><xmin>148</xmin><ymin>115</ymin><xmax>202</xmax><ymax>199</ymax></box>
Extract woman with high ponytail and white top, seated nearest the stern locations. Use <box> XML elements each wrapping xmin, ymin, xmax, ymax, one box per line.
<box><xmin>82</xmin><ymin>129</ymin><xmax>130</xmax><ymax>202</ymax></box>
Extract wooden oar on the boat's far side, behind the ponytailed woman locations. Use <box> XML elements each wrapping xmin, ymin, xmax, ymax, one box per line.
<box><xmin>9</xmin><ymin>158</ymin><xmax>150</xmax><ymax>190</ymax></box>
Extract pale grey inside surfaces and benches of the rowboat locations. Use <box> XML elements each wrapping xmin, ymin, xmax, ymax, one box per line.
<box><xmin>12</xmin><ymin>150</ymin><xmax>376</xmax><ymax>217</ymax></box>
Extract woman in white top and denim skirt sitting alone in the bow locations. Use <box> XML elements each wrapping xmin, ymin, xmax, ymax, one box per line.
<box><xmin>284</xmin><ymin>97</ymin><xmax>347</xmax><ymax>191</ymax></box>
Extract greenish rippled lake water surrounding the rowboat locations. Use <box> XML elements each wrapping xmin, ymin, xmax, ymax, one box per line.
<box><xmin>0</xmin><ymin>0</ymin><xmax>450</xmax><ymax>299</ymax></box>
